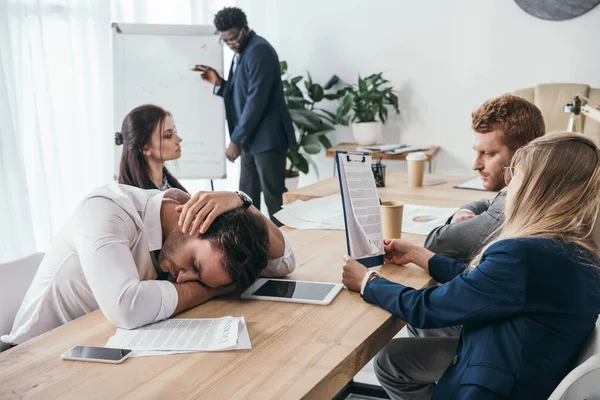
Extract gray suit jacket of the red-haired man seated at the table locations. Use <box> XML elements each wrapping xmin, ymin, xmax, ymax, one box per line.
<box><xmin>425</xmin><ymin>191</ymin><xmax>506</xmax><ymax>263</ymax></box>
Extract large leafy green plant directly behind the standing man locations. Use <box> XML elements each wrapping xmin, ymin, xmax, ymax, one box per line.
<box><xmin>280</xmin><ymin>61</ymin><xmax>341</xmax><ymax>189</ymax></box>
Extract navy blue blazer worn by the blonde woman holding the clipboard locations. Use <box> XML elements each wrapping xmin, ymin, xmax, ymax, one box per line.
<box><xmin>364</xmin><ymin>238</ymin><xmax>600</xmax><ymax>399</ymax></box>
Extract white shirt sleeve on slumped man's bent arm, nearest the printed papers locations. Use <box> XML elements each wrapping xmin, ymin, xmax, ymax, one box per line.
<box><xmin>75</xmin><ymin>198</ymin><xmax>178</xmax><ymax>329</ymax></box>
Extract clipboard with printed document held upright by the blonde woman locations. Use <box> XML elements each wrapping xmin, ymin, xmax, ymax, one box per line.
<box><xmin>335</xmin><ymin>151</ymin><xmax>385</xmax><ymax>268</ymax></box>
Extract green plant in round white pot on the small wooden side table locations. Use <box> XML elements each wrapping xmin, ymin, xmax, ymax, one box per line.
<box><xmin>337</xmin><ymin>72</ymin><xmax>400</xmax><ymax>146</ymax></box>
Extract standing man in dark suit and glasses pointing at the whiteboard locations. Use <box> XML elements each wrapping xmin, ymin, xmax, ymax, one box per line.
<box><xmin>200</xmin><ymin>7</ymin><xmax>296</xmax><ymax>226</ymax></box>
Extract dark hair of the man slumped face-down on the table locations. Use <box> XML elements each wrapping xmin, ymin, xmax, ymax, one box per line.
<box><xmin>200</xmin><ymin>208</ymin><xmax>269</xmax><ymax>288</ymax></box>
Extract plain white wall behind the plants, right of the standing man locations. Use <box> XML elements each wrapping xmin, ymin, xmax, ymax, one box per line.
<box><xmin>241</xmin><ymin>0</ymin><xmax>600</xmax><ymax>184</ymax></box>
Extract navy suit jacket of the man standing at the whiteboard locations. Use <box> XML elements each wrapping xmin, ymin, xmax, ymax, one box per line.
<box><xmin>216</xmin><ymin>31</ymin><xmax>296</xmax><ymax>154</ymax></box>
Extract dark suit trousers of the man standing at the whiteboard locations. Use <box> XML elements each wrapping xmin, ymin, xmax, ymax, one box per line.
<box><xmin>240</xmin><ymin>149</ymin><xmax>287</xmax><ymax>226</ymax></box>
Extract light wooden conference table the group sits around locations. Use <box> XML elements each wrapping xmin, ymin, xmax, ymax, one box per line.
<box><xmin>0</xmin><ymin>173</ymin><xmax>491</xmax><ymax>399</ymax></box>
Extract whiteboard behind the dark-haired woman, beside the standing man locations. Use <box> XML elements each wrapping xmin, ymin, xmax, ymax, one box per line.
<box><xmin>112</xmin><ymin>23</ymin><xmax>226</xmax><ymax>179</ymax></box>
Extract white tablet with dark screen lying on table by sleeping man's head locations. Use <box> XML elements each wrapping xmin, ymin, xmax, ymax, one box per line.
<box><xmin>242</xmin><ymin>278</ymin><xmax>342</xmax><ymax>305</ymax></box>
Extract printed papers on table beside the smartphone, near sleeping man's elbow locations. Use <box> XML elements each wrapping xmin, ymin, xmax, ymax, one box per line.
<box><xmin>105</xmin><ymin>317</ymin><xmax>252</xmax><ymax>357</ymax></box>
